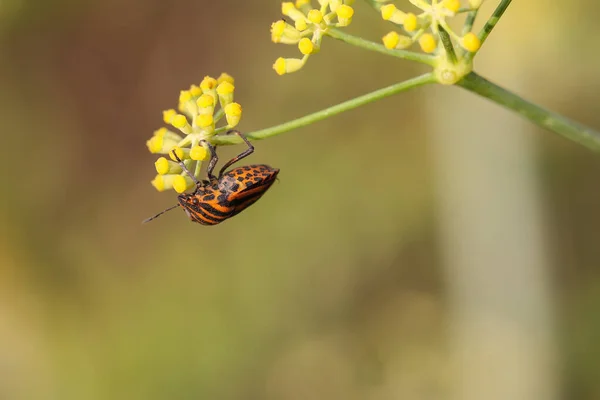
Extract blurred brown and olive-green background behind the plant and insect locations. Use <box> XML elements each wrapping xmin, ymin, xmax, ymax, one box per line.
<box><xmin>0</xmin><ymin>0</ymin><xmax>600</xmax><ymax>400</ymax></box>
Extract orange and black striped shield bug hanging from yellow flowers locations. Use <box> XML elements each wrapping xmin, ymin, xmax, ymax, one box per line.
<box><xmin>144</xmin><ymin>131</ymin><xmax>279</xmax><ymax>225</ymax></box>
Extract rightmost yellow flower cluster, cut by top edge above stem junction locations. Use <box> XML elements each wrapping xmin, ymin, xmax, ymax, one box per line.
<box><xmin>381</xmin><ymin>0</ymin><xmax>481</xmax><ymax>53</ymax></box>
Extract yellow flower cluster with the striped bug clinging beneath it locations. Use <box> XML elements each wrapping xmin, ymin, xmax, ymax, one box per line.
<box><xmin>146</xmin><ymin>73</ymin><xmax>242</xmax><ymax>193</ymax></box>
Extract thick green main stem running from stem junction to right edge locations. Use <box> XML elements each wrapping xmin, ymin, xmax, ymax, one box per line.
<box><xmin>457</xmin><ymin>72</ymin><xmax>600</xmax><ymax>152</ymax></box>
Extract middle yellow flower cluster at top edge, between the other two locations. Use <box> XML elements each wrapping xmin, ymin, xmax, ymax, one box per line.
<box><xmin>271</xmin><ymin>0</ymin><xmax>354</xmax><ymax>75</ymax></box>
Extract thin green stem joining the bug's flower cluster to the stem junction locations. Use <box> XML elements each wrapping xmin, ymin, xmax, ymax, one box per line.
<box><xmin>210</xmin><ymin>73</ymin><xmax>436</xmax><ymax>146</ymax></box>
